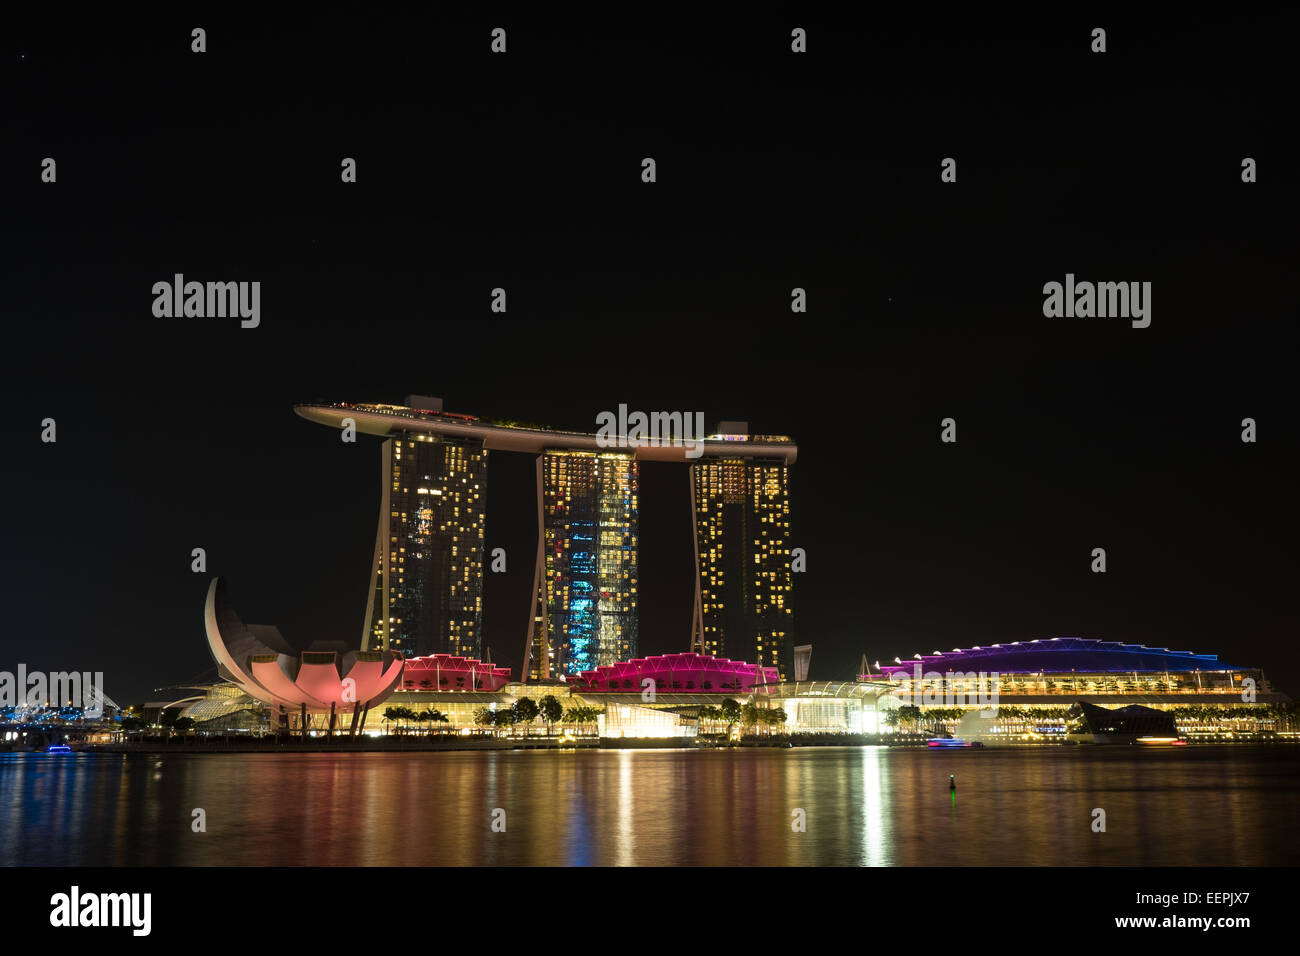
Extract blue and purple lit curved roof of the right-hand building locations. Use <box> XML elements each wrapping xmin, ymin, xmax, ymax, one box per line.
<box><xmin>880</xmin><ymin>637</ymin><xmax>1248</xmax><ymax>674</ymax></box>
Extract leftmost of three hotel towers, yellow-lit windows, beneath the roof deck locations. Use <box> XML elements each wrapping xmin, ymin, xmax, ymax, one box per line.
<box><xmin>363</xmin><ymin>433</ymin><xmax>488</xmax><ymax>658</ymax></box>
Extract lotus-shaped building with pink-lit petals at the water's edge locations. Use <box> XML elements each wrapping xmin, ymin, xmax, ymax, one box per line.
<box><xmin>204</xmin><ymin>578</ymin><xmax>403</xmax><ymax>734</ymax></box>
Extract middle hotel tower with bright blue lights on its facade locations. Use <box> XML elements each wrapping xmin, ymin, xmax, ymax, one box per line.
<box><xmin>527</xmin><ymin>451</ymin><xmax>637</xmax><ymax>680</ymax></box>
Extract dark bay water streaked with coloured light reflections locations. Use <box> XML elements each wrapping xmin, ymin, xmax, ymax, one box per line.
<box><xmin>0</xmin><ymin>745</ymin><xmax>1300</xmax><ymax>866</ymax></box>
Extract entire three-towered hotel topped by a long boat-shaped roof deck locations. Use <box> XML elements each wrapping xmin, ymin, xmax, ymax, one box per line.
<box><xmin>295</xmin><ymin>395</ymin><xmax>798</xmax><ymax>680</ymax></box>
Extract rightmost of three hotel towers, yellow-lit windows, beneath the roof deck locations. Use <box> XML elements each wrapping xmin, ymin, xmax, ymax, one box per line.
<box><xmin>690</xmin><ymin>454</ymin><xmax>794</xmax><ymax>679</ymax></box>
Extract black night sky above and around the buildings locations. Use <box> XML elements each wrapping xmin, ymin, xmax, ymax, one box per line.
<box><xmin>0</xmin><ymin>8</ymin><xmax>1300</xmax><ymax>702</ymax></box>
